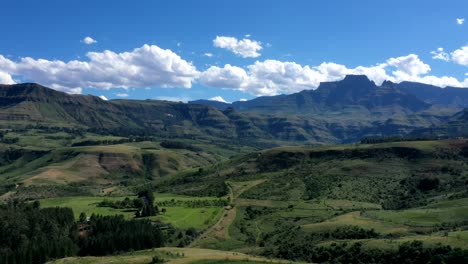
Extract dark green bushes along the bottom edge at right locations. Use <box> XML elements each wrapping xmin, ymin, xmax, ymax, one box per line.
<box><xmin>263</xmin><ymin>224</ymin><xmax>468</xmax><ymax>264</ymax></box>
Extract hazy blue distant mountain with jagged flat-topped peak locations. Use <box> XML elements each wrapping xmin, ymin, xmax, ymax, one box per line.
<box><xmin>191</xmin><ymin>75</ymin><xmax>431</xmax><ymax>115</ymax></box>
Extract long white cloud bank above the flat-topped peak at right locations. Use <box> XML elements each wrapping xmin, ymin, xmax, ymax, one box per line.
<box><xmin>199</xmin><ymin>54</ymin><xmax>468</xmax><ymax>96</ymax></box>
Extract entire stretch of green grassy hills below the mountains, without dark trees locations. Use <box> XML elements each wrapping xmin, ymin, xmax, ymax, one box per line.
<box><xmin>0</xmin><ymin>129</ymin><xmax>468</xmax><ymax>263</ymax></box>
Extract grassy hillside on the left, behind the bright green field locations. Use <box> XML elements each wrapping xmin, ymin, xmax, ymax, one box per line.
<box><xmin>0</xmin><ymin>128</ymin><xmax>251</xmax><ymax>199</ymax></box>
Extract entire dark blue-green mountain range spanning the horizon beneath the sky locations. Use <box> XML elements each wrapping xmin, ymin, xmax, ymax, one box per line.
<box><xmin>0</xmin><ymin>75</ymin><xmax>468</xmax><ymax>146</ymax></box>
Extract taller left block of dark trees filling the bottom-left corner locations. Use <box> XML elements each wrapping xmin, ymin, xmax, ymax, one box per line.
<box><xmin>0</xmin><ymin>201</ymin><xmax>78</xmax><ymax>264</ymax></box>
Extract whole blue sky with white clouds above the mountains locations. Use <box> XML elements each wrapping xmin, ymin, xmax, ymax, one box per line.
<box><xmin>0</xmin><ymin>0</ymin><xmax>468</xmax><ymax>102</ymax></box>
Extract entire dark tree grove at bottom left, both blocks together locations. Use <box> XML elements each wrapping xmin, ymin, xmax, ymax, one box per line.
<box><xmin>0</xmin><ymin>201</ymin><xmax>164</xmax><ymax>264</ymax></box>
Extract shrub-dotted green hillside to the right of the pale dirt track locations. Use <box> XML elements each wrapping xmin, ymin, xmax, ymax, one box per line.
<box><xmin>157</xmin><ymin>140</ymin><xmax>468</xmax><ymax>256</ymax></box>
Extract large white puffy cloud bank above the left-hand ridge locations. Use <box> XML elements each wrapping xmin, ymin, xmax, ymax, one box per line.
<box><xmin>0</xmin><ymin>45</ymin><xmax>199</xmax><ymax>93</ymax></box>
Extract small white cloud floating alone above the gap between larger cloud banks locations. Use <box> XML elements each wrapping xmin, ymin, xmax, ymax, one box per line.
<box><xmin>213</xmin><ymin>36</ymin><xmax>262</xmax><ymax>58</ymax></box>
